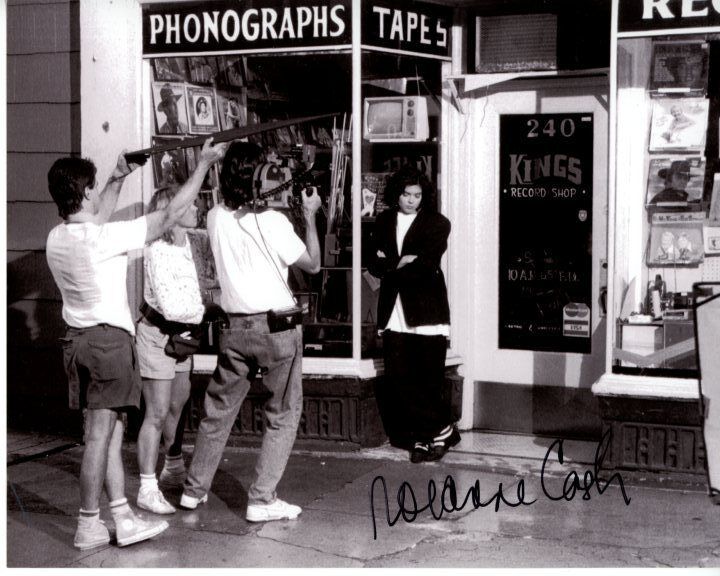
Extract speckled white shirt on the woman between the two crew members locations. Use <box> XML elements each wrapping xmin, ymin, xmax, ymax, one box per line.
<box><xmin>144</xmin><ymin>238</ymin><xmax>205</xmax><ymax>324</ymax></box>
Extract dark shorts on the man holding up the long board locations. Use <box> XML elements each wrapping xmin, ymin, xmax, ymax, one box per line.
<box><xmin>60</xmin><ymin>324</ymin><xmax>142</xmax><ymax>410</ymax></box>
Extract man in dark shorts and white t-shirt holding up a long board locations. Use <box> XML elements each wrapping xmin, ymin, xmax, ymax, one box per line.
<box><xmin>46</xmin><ymin>138</ymin><xmax>228</xmax><ymax>550</ymax></box>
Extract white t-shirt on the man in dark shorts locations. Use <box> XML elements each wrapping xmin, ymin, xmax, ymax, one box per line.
<box><xmin>47</xmin><ymin>216</ymin><xmax>147</xmax><ymax>334</ymax></box>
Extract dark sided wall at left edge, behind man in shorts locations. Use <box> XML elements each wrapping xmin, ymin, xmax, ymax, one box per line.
<box><xmin>6</xmin><ymin>0</ymin><xmax>81</xmax><ymax>429</ymax></box>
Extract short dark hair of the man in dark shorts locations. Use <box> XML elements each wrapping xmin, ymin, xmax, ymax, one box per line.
<box><xmin>48</xmin><ymin>157</ymin><xmax>97</xmax><ymax>220</ymax></box>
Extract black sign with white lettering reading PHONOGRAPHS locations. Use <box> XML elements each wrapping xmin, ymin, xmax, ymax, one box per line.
<box><xmin>142</xmin><ymin>0</ymin><xmax>351</xmax><ymax>56</ymax></box>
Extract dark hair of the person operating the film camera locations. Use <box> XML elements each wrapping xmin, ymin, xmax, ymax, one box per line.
<box><xmin>220</xmin><ymin>142</ymin><xmax>262</xmax><ymax>210</ymax></box>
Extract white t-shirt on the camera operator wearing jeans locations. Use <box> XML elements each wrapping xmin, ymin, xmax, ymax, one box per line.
<box><xmin>207</xmin><ymin>205</ymin><xmax>305</xmax><ymax>314</ymax></box>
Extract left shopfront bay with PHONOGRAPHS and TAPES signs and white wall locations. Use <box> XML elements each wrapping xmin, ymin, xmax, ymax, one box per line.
<box><xmin>80</xmin><ymin>0</ymin><xmax>462</xmax><ymax>445</ymax></box>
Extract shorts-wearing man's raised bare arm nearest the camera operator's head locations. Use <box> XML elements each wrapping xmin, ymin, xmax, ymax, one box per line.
<box><xmin>145</xmin><ymin>137</ymin><xmax>230</xmax><ymax>242</ymax></box>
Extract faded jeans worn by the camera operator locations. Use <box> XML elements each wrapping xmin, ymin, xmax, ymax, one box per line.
<box><xmin>185</xmin><ymin>314</ymin><xmax>302</xmax><ymax>504</ymax></box>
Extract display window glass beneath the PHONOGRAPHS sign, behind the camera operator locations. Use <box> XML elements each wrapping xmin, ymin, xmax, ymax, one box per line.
<box><xmin>150</xmin><ymin>54</ymin><xmax>353</xmax><ymax>357</ymax></box>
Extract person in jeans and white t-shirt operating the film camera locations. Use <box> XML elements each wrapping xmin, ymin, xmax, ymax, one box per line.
<box><xmin>180</xmin><ymin>142</ymin><xmax>320</xmax><ymax>522</ymax></box>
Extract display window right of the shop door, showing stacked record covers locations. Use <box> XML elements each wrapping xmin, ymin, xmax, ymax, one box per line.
<box><xmin>613</xmin><ymin>34</ymin><xmax>720</xmax><ymax>377</ymax></box>
